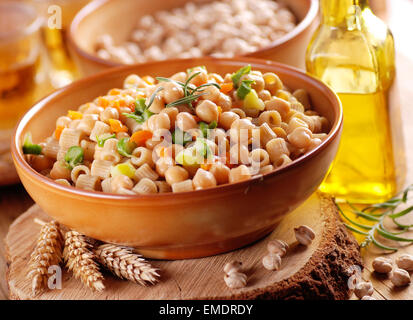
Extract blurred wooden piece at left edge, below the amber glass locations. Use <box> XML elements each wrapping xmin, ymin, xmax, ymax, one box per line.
<box><xmin>0</xmin><ymin>130</ymin><xmax>20</xmax><ymax>186</ymax></box>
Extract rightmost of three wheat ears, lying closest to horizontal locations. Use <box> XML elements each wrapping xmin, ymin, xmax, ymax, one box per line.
<box><xmin>95</xmin><ymin>244</ymin><xmax>159</xmax><ymax>286</ymax></box>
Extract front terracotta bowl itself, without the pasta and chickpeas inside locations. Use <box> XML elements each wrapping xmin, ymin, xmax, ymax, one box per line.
<box><xmin>12</xmin><ymin>58</ymin><xmax>343</xmax><ymax>259</ymax></box>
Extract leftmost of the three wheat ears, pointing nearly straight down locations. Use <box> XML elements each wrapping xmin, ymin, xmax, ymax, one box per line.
<box><xmin>27</xmin><ymin>221</ymin><xmax>63</xmax><ymax>295</ymax></box>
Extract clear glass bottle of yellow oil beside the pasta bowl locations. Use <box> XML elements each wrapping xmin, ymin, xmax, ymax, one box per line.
<box><xmin>306</xmin><ymin>0</ymin><xmax>396</xmax><ymax>203</ymax></box>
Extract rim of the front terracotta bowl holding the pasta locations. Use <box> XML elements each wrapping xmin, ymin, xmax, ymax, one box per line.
<box><xmin>11</xmin><ymin>57</ymin><xmax>343</xmax><ymax>201</ymax></box>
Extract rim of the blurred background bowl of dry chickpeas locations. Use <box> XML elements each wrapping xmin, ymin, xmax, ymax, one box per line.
<box><xmin>68</xmin><ymin>0</ymin><xmax>319</xmax><ymax>67</ymax></box>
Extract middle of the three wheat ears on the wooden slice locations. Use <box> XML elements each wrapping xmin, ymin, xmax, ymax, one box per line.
<box><xmin>63</xmin><ymin>231</ymin><xmax>105</xmax><ymax>291</ymax></box>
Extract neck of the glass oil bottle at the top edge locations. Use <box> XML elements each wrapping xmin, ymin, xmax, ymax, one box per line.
<box><xmin>320</xmin><ymin>0</ymin><xmax>369</xmax><ymax>25</ymax></box>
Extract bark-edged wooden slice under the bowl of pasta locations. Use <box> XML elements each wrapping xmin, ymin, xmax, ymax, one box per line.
<box><xmin>6</xmin><ymin>194</ymin><xmax>361</xmax><ymax>299</ymax></box>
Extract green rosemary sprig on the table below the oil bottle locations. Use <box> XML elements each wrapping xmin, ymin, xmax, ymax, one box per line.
<box><xmin>335</xmin><ymin>185</ymin><xmax>413</xmax><ymax>252</ymax></box>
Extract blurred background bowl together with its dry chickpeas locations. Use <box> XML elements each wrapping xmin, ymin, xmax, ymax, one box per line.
<box><xmin>69</xmin><ymin>0</ymin><xmax>319</xmax><ymax>75</ymax></box>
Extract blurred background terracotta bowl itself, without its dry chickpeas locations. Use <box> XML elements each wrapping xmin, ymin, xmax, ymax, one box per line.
<box><xmin>69</xmin><ymin>0</ymin><xmax>319</xmax><ymax>75</ymax></box>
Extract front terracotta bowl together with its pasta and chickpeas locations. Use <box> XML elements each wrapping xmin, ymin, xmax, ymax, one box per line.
<box><xmin>12</xmin><ymin>58</ymin><xmax>342</xmax><ymax>259</ymax></box>
